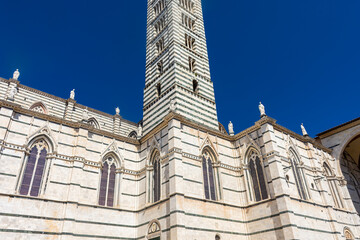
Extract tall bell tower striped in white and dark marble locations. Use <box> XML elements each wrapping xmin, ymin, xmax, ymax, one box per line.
<box><xmin>143</xmin><ymin>0</ymin><xmax>218</xmax><ymax>134</ymax></box>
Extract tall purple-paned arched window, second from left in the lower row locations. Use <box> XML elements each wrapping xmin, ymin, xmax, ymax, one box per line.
<box><xmin>99</xmin><ymin>155</ymin><xmax>116</xmax><ymax>207</ymax></box>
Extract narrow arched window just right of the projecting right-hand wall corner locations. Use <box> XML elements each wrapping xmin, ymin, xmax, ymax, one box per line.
<box><xmin>290</xmin><ymin>150</ymin><xmax>309</xmax><ymax>200</ymax></box>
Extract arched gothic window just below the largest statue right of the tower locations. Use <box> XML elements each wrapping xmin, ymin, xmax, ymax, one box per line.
<box><xmin>246</xmin><ymin>150</ymin><xmax>268</xmax><ymax>202</ymax></box>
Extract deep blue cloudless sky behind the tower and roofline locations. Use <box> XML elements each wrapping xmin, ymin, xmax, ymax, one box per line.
<box><xmin>0</xmin><ymin>0</ymin><xmax>360</xmax><ymax>136</ymax></box>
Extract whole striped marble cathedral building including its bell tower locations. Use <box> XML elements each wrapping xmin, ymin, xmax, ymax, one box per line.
<box><xmin>0</xmin><ymin>0</ymin><xmax>360</xmax><ymax>240</ymax></box>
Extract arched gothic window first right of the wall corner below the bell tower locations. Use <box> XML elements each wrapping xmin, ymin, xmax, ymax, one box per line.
<box><xmin>202</xmin><ymin>151</ymin><xmax>216</xmax><ymax>201</ymax></box>
